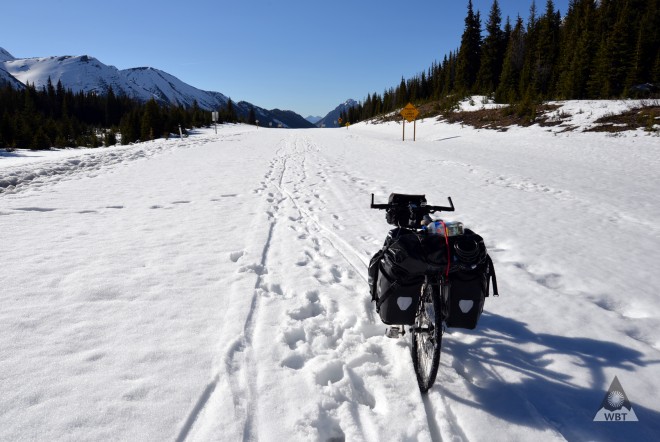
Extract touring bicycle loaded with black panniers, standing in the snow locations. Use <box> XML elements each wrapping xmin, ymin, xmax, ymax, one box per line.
<box><xmin>369</xmin><ymin>193</ymin><xmax>499</xmax><ymax>393</ymax></box>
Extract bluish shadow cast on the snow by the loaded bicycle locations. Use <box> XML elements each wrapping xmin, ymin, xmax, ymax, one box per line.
<box><xmin>434</xmin><ymin>312</ymin><xmax>660</xmax><ymax>441</ymax></box>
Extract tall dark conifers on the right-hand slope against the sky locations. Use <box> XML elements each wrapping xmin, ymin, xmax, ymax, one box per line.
<box><xmin>342</xmin><ymin>0</ymin><xmax>660</xmax><ymax>123</ymax></box>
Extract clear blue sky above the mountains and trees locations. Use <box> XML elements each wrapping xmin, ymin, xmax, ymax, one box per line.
<box><xmin>0</xmin><ymin>0</ymin><xmax>568</xmax><ymax>117</ymax></box>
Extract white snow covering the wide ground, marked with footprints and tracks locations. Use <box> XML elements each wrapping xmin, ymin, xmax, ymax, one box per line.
<box><xmin>0</xmin><ymin>108</ymin><xmax>660</xmax><ymax>441</ymax></box>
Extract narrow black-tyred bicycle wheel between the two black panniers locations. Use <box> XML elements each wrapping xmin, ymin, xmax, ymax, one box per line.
<box><xmin>411</xmin><ymin>282</ymin><xmax>442</xmax><ymax>393</ymax></box>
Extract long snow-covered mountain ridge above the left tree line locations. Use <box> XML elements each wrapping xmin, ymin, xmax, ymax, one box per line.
<box><xmin>0</xmin><ymin>48</ymin><xmax>309</xmax><ymax>127</ymax></box>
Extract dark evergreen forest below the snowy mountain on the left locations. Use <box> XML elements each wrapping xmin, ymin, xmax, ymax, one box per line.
<box><xmin>0</xmin><ymin>78</ymin><xmax>245</xmax><ymax>149</ymax></box>
